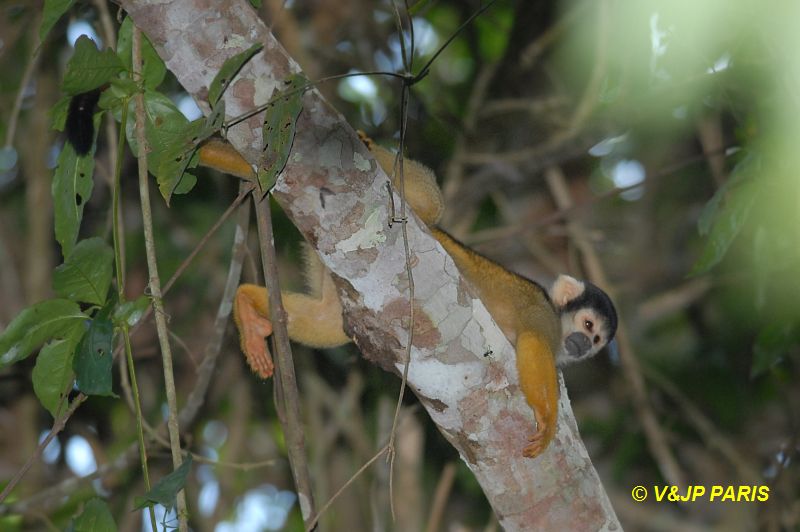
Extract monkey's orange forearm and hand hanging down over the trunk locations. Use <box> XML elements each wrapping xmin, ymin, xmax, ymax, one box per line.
<box><xmin>516</xmin><ymin>331</ymin><xmax>558</xmax><ymax>458</ymax></box>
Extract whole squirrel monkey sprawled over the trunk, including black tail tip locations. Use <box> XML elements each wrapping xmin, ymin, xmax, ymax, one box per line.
<box><xmin>67</xmin><ymin>91</ymin><xmax>617</xmax><ymax>458</ymax></box>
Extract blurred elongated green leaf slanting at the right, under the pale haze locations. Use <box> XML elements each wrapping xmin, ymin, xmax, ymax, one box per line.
<box><xmin>689</xmin><ymin>179</ymin><xmax>758</xmax><ymax>275</ymax></box>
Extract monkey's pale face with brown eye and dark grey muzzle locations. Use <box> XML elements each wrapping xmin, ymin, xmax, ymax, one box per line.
<box><xmin>556</xmin><ymin>308</ymin><xmax>611</xmax><ymax>366</ymax></box>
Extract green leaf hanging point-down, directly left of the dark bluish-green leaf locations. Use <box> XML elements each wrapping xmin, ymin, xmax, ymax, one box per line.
<box><xmin>31</xmin><ymin>327</ymin><xmax>85</xmax><ymax>418</ymax></box>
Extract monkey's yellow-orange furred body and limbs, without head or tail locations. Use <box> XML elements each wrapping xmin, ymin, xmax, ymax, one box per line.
<box><xmin>200</xmin><ymin>136</ymin><xmax>561</xmax><ymax>457</ymax></box>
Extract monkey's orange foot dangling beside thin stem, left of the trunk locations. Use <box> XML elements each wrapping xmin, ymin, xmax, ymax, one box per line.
<box><xmin>233</xmin><ymin>284</ymin><xmax>274</xmax><ymax>379</ymax></box>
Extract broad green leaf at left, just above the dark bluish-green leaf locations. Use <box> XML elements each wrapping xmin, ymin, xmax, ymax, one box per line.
<box><xmin>53</xmin><ymin>238</ymin><xmax>114</xmax><ymax>306</ymax></box>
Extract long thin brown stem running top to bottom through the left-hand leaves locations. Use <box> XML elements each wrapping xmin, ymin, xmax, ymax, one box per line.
<box><xmin>133</xmin><ymin>27</ymin><xmax>189</xmax><ymax>532</ymax></box>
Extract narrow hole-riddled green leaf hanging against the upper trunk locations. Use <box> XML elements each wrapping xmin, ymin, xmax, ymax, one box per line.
<box><xmin>257</xmin><ymin>74</ymin><xmax>308</xmax><ymax>194</ymax></box>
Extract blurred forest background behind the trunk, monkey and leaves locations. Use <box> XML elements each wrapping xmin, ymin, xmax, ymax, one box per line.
<box><xmin>0</xmin><ymin>0</ymin><xmax>800</xmax><ymax>530</ymax></box>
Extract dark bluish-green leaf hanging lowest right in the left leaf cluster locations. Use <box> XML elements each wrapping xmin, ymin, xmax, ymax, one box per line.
<box><xmin>72</xmin><ymin>318</ymin><xmax>114</xmax><ymax>396</ymax></box>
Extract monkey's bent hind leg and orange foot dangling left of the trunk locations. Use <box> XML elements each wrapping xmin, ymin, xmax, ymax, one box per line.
<box><xmin>233</xmin><ymin>274</ymin><xmax>350</xmax><ymax>379</ymax></box>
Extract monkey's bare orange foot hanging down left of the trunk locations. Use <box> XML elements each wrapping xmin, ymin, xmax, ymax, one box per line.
<box><xmin>233</xmin><ymin>290</ymin><xmax>274</xmax><ymax>379</ymax></box>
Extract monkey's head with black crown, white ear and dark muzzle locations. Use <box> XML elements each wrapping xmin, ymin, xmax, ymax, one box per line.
<box><xmin>550</xmin><ymin>275</ymin><xmax>617</xmax><ymax>366</ymax></box>
